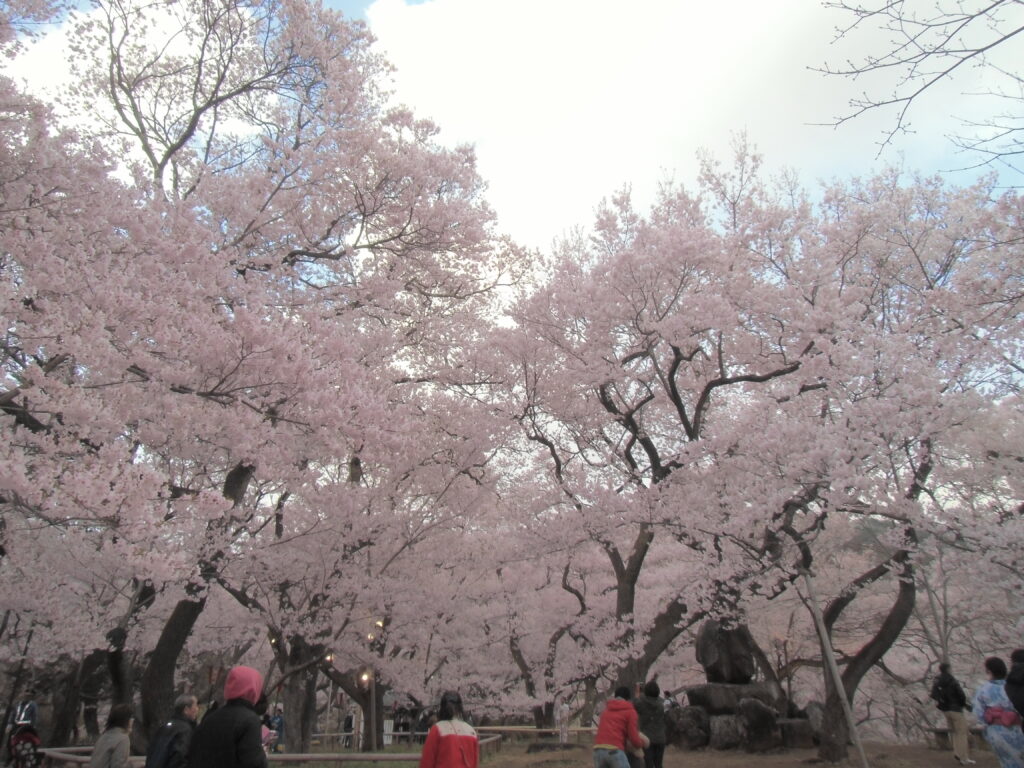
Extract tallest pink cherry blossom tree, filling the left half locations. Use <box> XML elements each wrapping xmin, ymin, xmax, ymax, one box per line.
<box><xmin>2</xmin><ymin>2</ymin><xmax>519</xmax><ymax>749</ymax></box>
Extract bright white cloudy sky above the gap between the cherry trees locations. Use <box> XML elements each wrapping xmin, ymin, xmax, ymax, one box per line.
<box><xmin>6</xmin><ymin>0</ymin><xmax>999</xmax><ymax>248</ymax></box>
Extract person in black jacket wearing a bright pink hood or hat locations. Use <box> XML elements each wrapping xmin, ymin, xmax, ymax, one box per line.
<box><xmin>188</xmin><ymin>667</ymin><xmax>266</xmax><ymax>768</ymax></box>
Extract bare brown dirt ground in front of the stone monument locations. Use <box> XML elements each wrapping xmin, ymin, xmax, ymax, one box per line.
<box><xmin>481</xmin><ymin>742</ymin><xmax>999</xmax><ymax>768</ymax></box>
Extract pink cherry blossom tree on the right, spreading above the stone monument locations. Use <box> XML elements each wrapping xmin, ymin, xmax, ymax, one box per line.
<box><xmin>491</xmin><ymin>141</ymin><xmax>1020</xmax><ymax>759</ymax></box>
